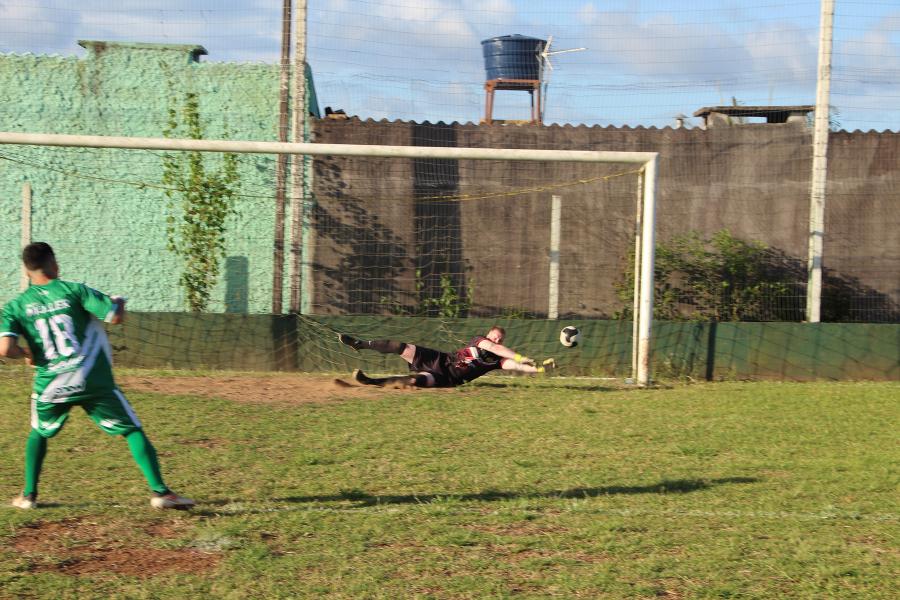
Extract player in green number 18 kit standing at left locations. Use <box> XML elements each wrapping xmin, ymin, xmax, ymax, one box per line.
<box><xmin>0</xmin><ymin>242</ymin><xmax>194</xmax><ymax>509</ymax></box>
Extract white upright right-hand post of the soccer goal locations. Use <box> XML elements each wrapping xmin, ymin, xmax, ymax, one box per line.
<box><xmin>637</xmin><ymin>156</ymin><xmax>659</xmax><ymax>386</ymax></box>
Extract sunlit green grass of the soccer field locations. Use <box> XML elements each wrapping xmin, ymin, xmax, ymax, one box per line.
<box><xmin>0</xmin><ymin>370</ymin><xmax>900</xmax><ymax>598</ymax></box>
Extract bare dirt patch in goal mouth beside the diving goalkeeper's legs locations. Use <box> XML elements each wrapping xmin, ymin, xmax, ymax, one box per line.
<box><xmin>116</xmin><ymin>373</ymin><xmax>447</xmax><ymax>404</ymax></box>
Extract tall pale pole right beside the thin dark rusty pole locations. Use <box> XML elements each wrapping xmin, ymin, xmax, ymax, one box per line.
<box><xmin>291</xmin><ymin>0</ymin><xmax>308</xmax><ymax>313</ymax></box>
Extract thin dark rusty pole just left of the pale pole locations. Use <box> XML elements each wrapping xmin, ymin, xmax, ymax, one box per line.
<box><xmin>272</xmin><ymin>0</ymin><xmax>291</xmax><ymax>315</ymax></box>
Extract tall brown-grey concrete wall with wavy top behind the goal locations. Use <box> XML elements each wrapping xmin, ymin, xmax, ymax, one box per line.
<box><xmin>316</xmin><ymin>120</ymin><xmax>900</xmax><ymax>320</ymax></box>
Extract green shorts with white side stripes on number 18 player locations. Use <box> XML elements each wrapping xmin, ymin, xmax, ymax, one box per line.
<box><xmin>31</xmin><ymin>388</ymin><xmax>141</xmax><ymax>438</ymax></box>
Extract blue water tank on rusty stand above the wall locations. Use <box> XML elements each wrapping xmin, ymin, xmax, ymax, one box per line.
<box><xmin>481</xmin><ymin>34</ymin><xmax>547</xmax><ymax>125</ymax></box>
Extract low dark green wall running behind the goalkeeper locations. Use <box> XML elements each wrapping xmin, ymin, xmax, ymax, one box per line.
<box><xmin>110</xmin><ymin>313</ymin><xmax>900</xmax><ymax>381</ymax></box>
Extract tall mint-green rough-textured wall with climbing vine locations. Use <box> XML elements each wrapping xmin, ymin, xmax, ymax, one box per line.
<box><xmin>0</xmin><ymin>42</ymin><xmax>318</xmax><ymax>313</ymax></box>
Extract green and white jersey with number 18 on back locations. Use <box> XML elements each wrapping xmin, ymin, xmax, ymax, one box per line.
<box><xmin>0</xmin><ymin>279</ymin><xmax>116</xmax><ymax>402</ymax></box>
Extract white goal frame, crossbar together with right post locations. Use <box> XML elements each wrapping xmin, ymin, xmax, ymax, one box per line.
<box><xmin>0</xmin><ymin>132</ymin><xmax>659</xmax><ymax>386</ymax></box>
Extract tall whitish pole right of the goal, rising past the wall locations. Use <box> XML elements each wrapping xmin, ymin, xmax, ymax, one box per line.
<box><xmin>806</xmin><ymin>0</ymin><xmax>834</xmax><ymax>323</ymax></box>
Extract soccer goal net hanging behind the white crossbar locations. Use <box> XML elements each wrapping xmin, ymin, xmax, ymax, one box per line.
<box><xmin>0</xmin><ymin>134</ymin><xmax>656</xmax><ymax>382</ymax></box>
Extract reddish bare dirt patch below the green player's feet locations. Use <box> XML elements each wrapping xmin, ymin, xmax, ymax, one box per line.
<box><xmin>12</xmin><ymin>517</ymin><xmax>221</xmax><ymax>577</ymax></box>
